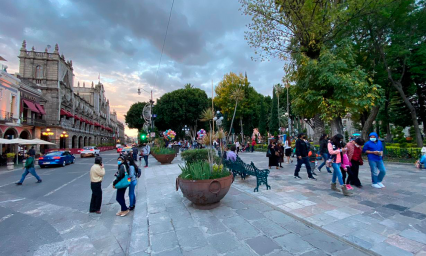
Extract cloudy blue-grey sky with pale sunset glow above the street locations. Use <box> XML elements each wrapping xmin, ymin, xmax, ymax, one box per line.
<box><xmin>0</xmin><ymin>0</ymin><xmax>284</xmax><ymax>136</ymax></box>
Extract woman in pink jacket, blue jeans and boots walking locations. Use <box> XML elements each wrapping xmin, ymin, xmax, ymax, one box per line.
<box><xmin>327</xmin><ymin>134</ymin><xmax>352</xmax><ymax>196</ymax></box>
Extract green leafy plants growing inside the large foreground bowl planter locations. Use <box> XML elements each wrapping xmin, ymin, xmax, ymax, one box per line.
<box><xmin>179</xmin><ymin>161</ymin><xmax>230</xmax><ymax>180</ymax></box>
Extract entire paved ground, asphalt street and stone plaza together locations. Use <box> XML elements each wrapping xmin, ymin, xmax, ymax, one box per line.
<box><xmin>0</xmin><ymin>152</ymin><xmax>426</xmax><ymax>256</ymax></box>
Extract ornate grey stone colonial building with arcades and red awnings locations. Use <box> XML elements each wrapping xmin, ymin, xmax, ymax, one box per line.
<box><xmin>18</xmin><ymin>41</ymin><xmax>124</xmax><ymax>148</ymax></box>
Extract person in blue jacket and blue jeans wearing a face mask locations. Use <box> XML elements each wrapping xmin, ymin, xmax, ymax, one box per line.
<box><xmin>362</xmin><ymin>132</ymin><xmax>386</xmax><ymax>188</ymax></box>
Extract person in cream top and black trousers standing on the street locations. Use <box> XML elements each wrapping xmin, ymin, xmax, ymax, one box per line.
<box><xmin>89</xmin><ymin>156</ymin><xmax>105</xmax><ymax>214</ymax></box>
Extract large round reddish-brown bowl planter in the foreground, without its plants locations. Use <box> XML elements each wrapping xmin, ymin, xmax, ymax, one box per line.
<box><xmin>176</xmin><ymin>174</ymin><xmax>233</xmax><ymax>205</ymax></box>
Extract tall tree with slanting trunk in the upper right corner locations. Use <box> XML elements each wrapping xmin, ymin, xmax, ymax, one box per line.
<box><xmin>356</xmin><ymin>0</ymin><xmax>426</xmax><ymax>147</ymax></box>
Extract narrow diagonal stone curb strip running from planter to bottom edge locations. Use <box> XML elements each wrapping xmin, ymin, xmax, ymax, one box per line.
<box><xmin>234</xmin><ymin>186</ymin><xmax>382</xmax><ymax>256</ymax></box>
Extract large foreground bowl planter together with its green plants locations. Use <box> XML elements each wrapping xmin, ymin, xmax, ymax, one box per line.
<box><xmin>176</xmin><ymin>109</ymin><xmax>233</xmax><ymax>205</ymax></box>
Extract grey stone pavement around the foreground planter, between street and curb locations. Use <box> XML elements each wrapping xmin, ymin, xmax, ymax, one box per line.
<box><xmin>129</xmin><ymin>155</ymin><xmax>367</xmax><ymax>256</ymax></box>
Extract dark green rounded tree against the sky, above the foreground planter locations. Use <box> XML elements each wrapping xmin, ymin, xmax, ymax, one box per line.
<box><xmin>154</xmin><ymin>85</ymin><xmax>209</xmax><ymax>137</ymax></box>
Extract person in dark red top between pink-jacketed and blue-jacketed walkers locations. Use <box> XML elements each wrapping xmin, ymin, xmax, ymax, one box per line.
<box><xmin>346</xmin><ymin>138</ymin><xmax>365</xmax><ymax>188</ymax></box>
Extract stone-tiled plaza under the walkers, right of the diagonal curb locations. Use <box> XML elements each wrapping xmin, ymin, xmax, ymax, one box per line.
<box><xmin>233</xmin><ymin>152</ymin><xmax>426</xmax><ymax>256</ymax></box>
